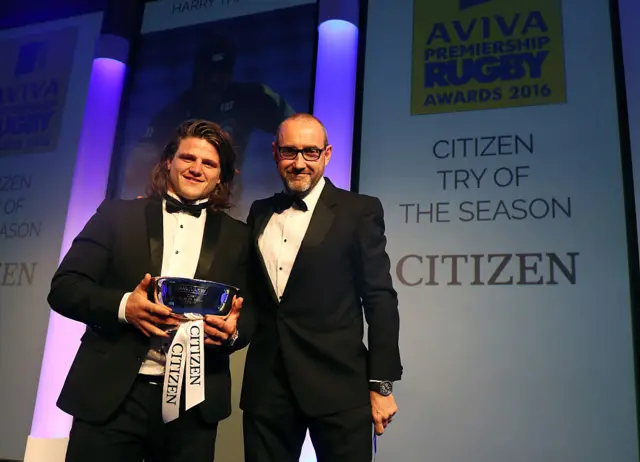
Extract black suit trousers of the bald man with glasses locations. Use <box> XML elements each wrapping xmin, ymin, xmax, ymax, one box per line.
<box><xmin>243</xmin><ymin>355</ymin><xmax>373</xmax><ymax>462</ymax></box>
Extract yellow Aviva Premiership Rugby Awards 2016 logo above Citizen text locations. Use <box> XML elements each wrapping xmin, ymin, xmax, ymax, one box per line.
<box><xmin>411</xmin><ymin>0</ymin><xmax>566</xmax><ymax>115</ymax></box>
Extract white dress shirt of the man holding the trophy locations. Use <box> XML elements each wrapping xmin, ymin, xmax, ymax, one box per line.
<box><xmin>118</xmin><ymin>193</ymin><xmax>207</xmax><ymax>375</ymax></box>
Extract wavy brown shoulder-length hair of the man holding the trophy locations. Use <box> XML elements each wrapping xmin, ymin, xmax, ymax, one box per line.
<box><xmin>146</xmin><ymin>119</ymin><xmax>236</xmax><ymax>209</ymax></box>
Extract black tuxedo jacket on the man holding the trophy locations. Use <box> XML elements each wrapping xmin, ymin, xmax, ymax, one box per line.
<box><xmin>48</xmin><ymin>199</ymin><xmax>250</xmax><ymax>422</ymax></box>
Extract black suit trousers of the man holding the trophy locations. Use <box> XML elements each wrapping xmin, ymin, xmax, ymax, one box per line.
<box><xmin>66</xmin><ymin>378</ymin><xmax>218</xmax><ymax>462</ymax></box>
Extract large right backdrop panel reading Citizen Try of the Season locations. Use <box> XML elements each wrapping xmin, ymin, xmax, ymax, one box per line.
<box><xmin>359</xmin><ymin>0</ymin><xmax>638</xmax><ymax>462</ymax></box>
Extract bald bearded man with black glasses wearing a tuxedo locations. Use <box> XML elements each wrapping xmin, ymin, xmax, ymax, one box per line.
<box><xmin>240</xmin><ymin>114</ymin><xmax>402</xmax><ymax>462</ymax></box>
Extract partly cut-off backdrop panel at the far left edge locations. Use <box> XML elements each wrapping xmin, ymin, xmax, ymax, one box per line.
<box><xmin>0</xmin><ymin>13</ymin><xmax>102</xmax><ymax>459</ymax></box>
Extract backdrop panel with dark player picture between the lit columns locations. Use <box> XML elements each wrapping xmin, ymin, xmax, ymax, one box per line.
<box><xmin>112</xmin><ymin>0</ymin><xmax>317</xmax><ymax>462</ymax></box>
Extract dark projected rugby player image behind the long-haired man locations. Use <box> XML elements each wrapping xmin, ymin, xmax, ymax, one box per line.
<box><xmin>121</xmin><ymin>35</ymin><xmax>295</xmax><ymax>203</ymax></box>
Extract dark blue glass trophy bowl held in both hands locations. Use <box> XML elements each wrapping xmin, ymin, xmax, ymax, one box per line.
<box><xmin>147</xmin><ymin>277</ymin><xmax>239</xmax><ymax>327</ymax></box>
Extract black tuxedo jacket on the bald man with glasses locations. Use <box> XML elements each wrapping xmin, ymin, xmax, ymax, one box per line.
<box><xmin>240</xmin><ymin>179</ymin><xmax>402</xmax><ymax>416</ymax></box>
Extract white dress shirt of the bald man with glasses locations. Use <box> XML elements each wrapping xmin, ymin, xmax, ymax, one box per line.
<box><xmin>258</xmin><ymin>178</ymin><xmax>325</xmax><ymax>298</ymax></box>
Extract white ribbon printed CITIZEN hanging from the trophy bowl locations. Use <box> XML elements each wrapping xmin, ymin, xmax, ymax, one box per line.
<box><xmin>162</xmin><ymin>314</ymin><xmax>204</xmax><ymax>423</ymax></box>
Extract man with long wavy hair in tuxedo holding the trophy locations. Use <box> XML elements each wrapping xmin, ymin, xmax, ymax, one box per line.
<box><xmin>48</xmin><ymin>120</ymin><xmax>250</xmax><ymax>462</ymax></box>
